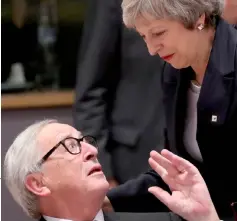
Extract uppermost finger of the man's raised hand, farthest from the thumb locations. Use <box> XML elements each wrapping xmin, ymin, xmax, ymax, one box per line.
<box><xmin>161</xmin><ymin>149</ymin><xmax>198</xmax><ymax>175</ymax></box>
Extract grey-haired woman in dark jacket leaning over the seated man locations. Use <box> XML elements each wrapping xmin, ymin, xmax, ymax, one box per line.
<box><xmin>105</xmin><ymin>0</ymin><xmax>237</xmax><ymax>218</ymax></box>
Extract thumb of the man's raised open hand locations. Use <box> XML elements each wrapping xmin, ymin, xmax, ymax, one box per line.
<box><xmin>148</xmin><ymin>186</ymin><xmax>173</xmax><ymax>208</ymax></box>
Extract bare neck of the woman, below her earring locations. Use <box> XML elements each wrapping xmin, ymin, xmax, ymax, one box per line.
<box><xmin>191</xmin><ymin>28</ymin><xmax>215</xmax><ymax>85</ymax></box>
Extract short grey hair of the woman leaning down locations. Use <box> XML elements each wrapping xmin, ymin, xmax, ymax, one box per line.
<box><xmin>122</xmin><ymin>0</ymin><xmax>224</xmax><ymax>29</ymax></box>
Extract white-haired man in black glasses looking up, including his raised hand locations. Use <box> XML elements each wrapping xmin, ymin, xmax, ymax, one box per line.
<box><xmin>4</xmin><ymin>120</ymin><xmax>232</xmax><ymax>221</ymax></box>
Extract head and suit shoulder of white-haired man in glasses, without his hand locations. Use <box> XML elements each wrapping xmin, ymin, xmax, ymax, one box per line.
<box><xmin>4</xmin><ymin>120</ymin><xmax>180</xmax><ymax>221</ymax></box>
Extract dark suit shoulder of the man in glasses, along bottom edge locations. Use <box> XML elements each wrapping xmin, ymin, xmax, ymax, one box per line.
<box><xmin>39</xmin><ymin>212</ymin><xmax>181</xmax><ymax>221</ymax></box>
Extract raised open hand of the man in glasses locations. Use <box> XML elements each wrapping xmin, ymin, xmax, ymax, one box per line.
<box><xmin>148</xmin><ymin>150</ymin><xmax>219</xmax><ymax>221</ymax></box>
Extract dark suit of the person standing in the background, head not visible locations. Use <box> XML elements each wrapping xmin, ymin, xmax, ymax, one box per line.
<box><xmin>73</xmin><ymin>0</ymin><xmax>164</xmax><ymax>183</ymax></box>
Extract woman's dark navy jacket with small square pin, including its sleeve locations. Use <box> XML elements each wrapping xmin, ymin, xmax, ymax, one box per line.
<box><xmin>108</xmin><ymin>16</ymin><xmax>237</xmax><ymax>217</ymax></box>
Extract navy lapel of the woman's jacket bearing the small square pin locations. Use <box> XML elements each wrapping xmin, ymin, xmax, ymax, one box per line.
<box><xmin>197</xmin><ymin>66</ymin><xmax>234</xmax><ymax>128</ymax></box>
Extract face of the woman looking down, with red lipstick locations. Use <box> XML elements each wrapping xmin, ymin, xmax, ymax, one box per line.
<box><xmin>135</xmin><ymin>16</ymin><xmax>204</xmax><ymax>69</ymax></box>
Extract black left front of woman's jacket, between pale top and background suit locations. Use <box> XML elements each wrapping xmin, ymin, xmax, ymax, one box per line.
<box><xmin>163</xmin><ymin>64</ymin><xmax>192</xmax><ymax>161</ymax></box>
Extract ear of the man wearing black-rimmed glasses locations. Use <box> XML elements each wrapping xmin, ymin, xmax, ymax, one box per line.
<box><xmin>25</xmin><ymin>173</ymin><xmax>51</xmax><ymax>196</ymax></box>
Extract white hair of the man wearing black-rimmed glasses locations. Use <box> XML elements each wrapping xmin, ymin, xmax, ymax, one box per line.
<box><xmin>4</xmin><ymin>119</ymin><xmax>57</xmax><ymax>219</ymax></box>
